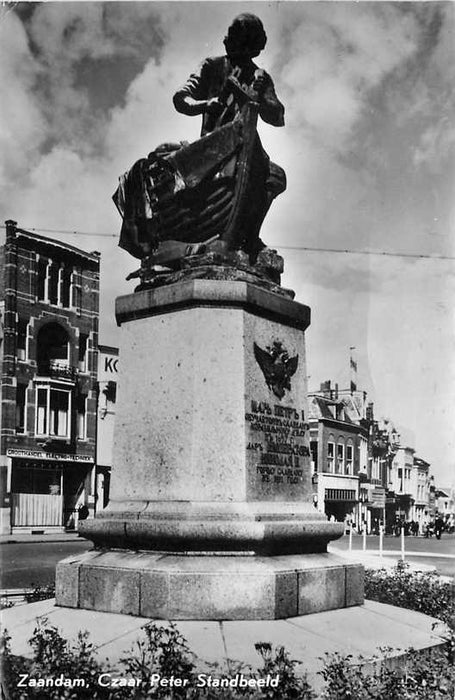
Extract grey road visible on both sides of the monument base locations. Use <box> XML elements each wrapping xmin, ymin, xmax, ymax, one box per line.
<box><xmin>0</xmin><ymin>535</ymin><xmax>455</xmax><ymax>589</ymax></box>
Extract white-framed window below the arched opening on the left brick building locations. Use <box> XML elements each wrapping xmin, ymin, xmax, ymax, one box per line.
<box><xmin>36</xmin><ymin>386</ymin><xmax>71</xmax><ymax>438</ymax></box>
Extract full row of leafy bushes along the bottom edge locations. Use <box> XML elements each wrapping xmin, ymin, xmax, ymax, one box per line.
<box><xmin>2</xmin><ymin>620</ymin><xmax>455</xmax><ymax>700</ymax></box>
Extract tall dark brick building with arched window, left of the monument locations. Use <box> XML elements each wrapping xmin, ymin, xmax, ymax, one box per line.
<box><xmin>0</xmin><ymin>221</ymin><xmax>99</xmax><ymax>534</ymax></box>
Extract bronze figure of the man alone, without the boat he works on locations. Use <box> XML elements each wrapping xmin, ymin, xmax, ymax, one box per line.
<box><xmin>174</xmin><ymin>13</ymin><xmax>286</xmax><ymax>261</ymax></box>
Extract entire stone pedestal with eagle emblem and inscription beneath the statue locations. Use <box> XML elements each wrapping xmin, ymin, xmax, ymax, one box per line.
<box><xmin>57</xmin><ymin>279</ymin><xmax>363</xmax><ymax>619</ymax></box>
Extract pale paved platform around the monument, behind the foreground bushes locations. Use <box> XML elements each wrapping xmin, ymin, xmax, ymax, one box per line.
<box><xmin>2</xmin><ymin>600</ymin><xmax>446</xmax><ymax>697</ymax></box>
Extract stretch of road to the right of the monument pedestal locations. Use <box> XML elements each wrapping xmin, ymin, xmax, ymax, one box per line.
<box><xmin>331</xmin><ymin>534</ymin><xmax>455</xmax><ymax>578</ymax></box>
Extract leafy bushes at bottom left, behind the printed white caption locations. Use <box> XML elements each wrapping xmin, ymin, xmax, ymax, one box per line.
<box><xmin>2</xmin><ymin>619</ymin><xmax>316</xmax><ymax>700</ymax></box>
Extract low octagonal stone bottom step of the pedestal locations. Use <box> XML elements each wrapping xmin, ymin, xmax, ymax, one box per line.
<box><xmin>56</xmin><ymin>550</ymin><xmax>364</xmax><ymax>620</ymax></box>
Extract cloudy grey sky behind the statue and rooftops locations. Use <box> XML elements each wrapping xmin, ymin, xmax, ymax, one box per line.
<box><xmin>0</xmin><ymin>1</ymin><xmax>455</xmax><ymax>484</ymax></box>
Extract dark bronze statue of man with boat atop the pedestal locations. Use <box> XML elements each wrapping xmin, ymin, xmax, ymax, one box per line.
<box><xmin>113</xmin><ymin>14</ymin><xmax>292</xmax><ymax>295</ymax></box>
